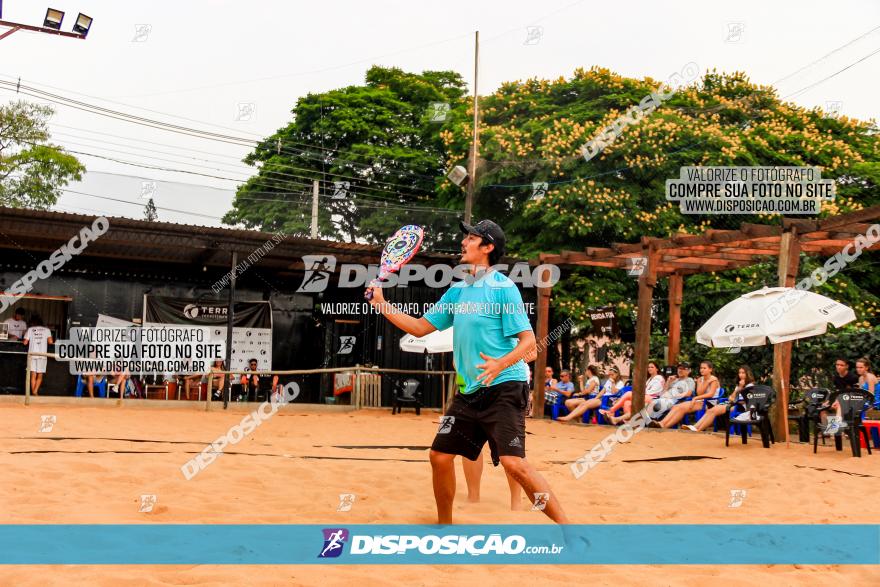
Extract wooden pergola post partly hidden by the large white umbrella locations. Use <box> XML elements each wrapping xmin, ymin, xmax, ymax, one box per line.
<box><xmin>770</xmin><ymin>226</ymin><xmax>801</xmax><ymax>442</ymax></box>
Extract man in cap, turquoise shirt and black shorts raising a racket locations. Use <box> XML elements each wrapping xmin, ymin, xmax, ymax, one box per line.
<box><xmin>370</xmin><ymin>220</ymin><xmax>568</xmax><ymax>524</ymax></box>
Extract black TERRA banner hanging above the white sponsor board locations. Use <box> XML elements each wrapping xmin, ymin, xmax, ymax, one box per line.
<box><xmin>144</xmin><ymin>295</ymin><xmax>272</xmax><ymax>329</ymax></box>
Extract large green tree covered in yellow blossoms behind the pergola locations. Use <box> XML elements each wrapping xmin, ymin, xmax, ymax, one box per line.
<box><xmin>440</xmin><ymin>67</ymin><xmax>880</xmax><ymax>334</ymax></box>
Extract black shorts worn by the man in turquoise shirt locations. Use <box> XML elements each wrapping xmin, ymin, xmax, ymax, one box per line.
<box><xmin>431</xmin><ymin>381</ymin><xmax>530</xmax><ymax>466</ymax></box>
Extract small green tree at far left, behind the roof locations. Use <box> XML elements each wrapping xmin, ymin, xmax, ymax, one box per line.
<box><xmin>0</xmin><ymin>102</ymin><xmax>85</xmax><ymax>210</ymax></box>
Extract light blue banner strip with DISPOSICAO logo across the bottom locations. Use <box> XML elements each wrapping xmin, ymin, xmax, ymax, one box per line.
<box><xmin>0</xmin><ymin>524</ymin><xmax>880</xmax><ymax>565</ymax></box>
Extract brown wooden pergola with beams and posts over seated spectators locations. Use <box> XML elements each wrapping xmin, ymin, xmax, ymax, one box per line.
<box><xmin>534</xmin><ymin>206</ymin><xmax>880</xmax><ymax>440</ymax></box>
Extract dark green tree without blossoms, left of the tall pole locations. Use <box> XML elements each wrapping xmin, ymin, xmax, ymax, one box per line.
<box><xmin>224</xmin><ymin>67</ymin><xmax>465</xmax><ymax>244</ymax></box>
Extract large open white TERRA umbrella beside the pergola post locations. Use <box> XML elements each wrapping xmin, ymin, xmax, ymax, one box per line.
<box><xmin>697</xmin><ymin>287</ymin><xmax>856</xmax><ymax>347</ymax></box>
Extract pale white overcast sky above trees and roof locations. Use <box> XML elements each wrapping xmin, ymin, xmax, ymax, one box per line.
<box><xmin>0</xmin><ymin>0</ymin><xmax>880</xmax><ymax>225</ymax></box>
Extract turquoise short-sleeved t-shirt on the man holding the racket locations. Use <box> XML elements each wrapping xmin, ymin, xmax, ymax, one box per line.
<box><xmin>424</xmin><ymin>271</ymin><xmax>532</xmax><ymax>394</ymax></box>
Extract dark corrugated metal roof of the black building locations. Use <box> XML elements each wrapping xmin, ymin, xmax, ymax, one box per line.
<box><xmin>0</xmin><ymin>207</ymin><xmax>457</xmax><ymax>273</ymax></box>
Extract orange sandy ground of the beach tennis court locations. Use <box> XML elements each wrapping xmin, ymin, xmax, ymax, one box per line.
<box><xmin>0</xmin><ymin>400</ymin><xmax>880</xmax><ymax>586</ymax></box>
